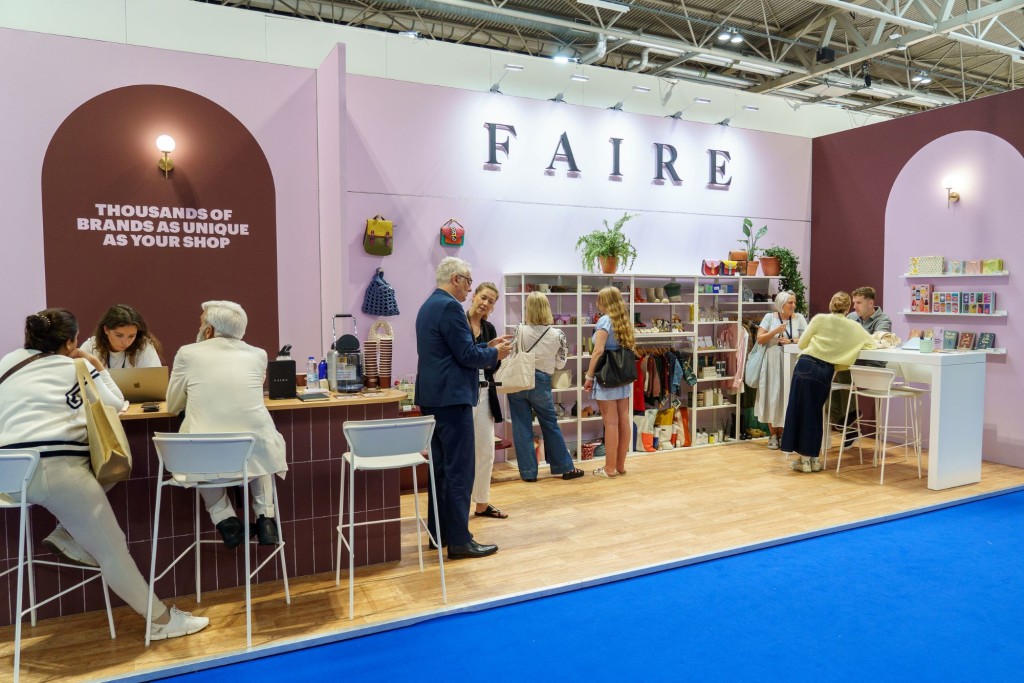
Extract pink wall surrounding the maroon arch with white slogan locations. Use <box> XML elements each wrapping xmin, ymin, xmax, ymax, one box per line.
<box><xmin>0</xmin><ymin>29</ymin><xmax>319</xmax><ymax>360</ymax></box>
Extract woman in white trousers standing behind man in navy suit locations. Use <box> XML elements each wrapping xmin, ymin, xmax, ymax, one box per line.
<box><xmin>466</xmin><ymin>283</ymin><xmax>508</xmax><ymax>519</ymax></box>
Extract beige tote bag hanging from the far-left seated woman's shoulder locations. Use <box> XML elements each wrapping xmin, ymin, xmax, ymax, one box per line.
<box><xmin>75</xmin><ymin>358</ymin><xmax>131</xmax><ymax>485</ymax></box>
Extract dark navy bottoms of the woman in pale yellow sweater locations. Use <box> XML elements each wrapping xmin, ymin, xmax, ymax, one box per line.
<box><xmin>779</xmin><ymin>355</ymin><xmax>836</xmax><ymax>458</ymax></box>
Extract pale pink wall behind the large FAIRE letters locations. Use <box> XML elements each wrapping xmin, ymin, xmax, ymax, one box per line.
<box><xmin>345</xmin><ymin>76</ymin><xmax>810</xmax><ymax>378</ymax></box>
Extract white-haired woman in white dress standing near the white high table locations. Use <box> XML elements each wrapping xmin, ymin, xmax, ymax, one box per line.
<box><xmin>754</xmin><ymin>292</ymin><xmax>807</xmax><ymax>451</ymax></box>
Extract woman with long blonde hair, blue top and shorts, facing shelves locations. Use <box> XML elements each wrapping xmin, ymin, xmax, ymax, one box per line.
<box><xmin>583</xmin><ymin>287</ymin><xmax>636</xmax><ymax>479</ymax></box>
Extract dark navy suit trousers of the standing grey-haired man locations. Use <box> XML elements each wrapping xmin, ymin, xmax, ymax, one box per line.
<box><xmin>420</xmin><ymin>405</ymin><xmax>476</xmax><ymax>546</ymax></box>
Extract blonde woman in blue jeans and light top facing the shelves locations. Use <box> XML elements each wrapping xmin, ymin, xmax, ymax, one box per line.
<box><xmin>509</xmin><ymin>292</ymin><xmax>584</xmax><ymax>481</ymax></box>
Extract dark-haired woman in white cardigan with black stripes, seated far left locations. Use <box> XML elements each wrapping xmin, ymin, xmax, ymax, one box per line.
<box><xmin>0</xmin><ymin>308</ymin><xmax>210</xmax><ymax>640</ymax></box>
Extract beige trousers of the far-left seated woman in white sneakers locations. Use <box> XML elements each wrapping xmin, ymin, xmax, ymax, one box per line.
<box><xmin>29</xmin><ymin>456</ymin><xmax>167</xmax><ymax>620</ymax></box>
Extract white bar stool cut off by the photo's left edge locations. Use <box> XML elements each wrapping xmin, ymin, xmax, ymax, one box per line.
<box><xmin>0</xmin><ymin>449</ymin><xmax>117</xmax><ymax>683</ymax></box>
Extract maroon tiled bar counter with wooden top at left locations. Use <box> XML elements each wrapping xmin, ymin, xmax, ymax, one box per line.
<box><xmin>0</xmin><ymin>390</ymin><xmax>404</xmax><ymax>626</ymax></box>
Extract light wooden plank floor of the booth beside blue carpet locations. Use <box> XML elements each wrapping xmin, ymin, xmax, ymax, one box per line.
<box><xmin>0</xmin><ymin>441</ymin><xmax>1024</xmax><ymax>681</ymax></box>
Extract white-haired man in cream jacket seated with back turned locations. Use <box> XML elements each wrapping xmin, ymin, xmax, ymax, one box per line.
<box><xmin>167</xmin><ymin>301</ymin><xmax>288</xmax><ymax>548</ymax></box>
